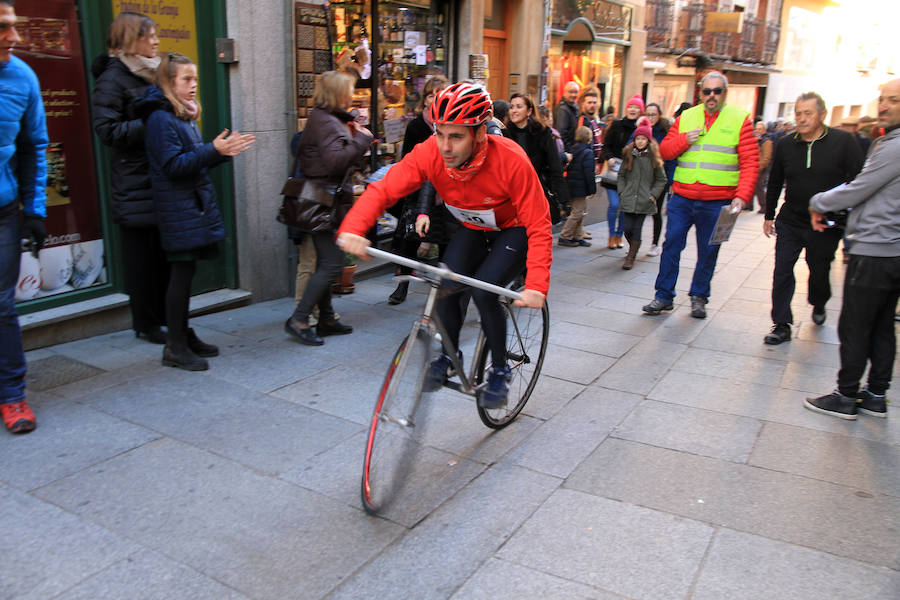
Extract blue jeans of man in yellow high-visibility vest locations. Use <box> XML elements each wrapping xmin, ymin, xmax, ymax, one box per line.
<box><xmin>656</xmin><ymin>194</ymin><xmax>731</xmax><ymax>302</ymax></box>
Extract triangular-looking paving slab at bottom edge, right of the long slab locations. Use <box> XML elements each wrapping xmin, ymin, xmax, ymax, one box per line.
<box><xmin>451</xmin><ymin>558</ymin><xmax>622</xmax><ymax>600</ymax></box>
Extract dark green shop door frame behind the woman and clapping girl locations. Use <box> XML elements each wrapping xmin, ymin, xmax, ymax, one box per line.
<box><xmin>16</xmin><ymin>0</ymin><xmax>238</xmax><ymax>314</ymax></box>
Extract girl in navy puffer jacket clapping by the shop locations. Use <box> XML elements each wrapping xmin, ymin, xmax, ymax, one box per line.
<box><xmin>137</xmin><ymin>53</ymin><xmax>256</xmax><ymax>371</ymax></box>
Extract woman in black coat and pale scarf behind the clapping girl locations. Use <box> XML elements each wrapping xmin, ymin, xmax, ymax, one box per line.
<box><xmin>91</xmin><ymin>12</ymin><xmax>169</xmax><ymax>344</ymax></box>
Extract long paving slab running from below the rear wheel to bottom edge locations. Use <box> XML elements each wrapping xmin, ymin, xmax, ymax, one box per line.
<box><xmin>329</xmin><ymin>464</ymin><xmax>559</xmax><ymax>600</ymax></box>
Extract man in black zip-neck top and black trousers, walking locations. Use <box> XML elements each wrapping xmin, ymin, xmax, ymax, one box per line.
<box><xmin>763</xmin><ymin>92</ymin><xmax>862</xmax><ymax>345</ymax></box>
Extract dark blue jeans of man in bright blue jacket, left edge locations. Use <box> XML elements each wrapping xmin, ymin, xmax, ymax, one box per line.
<box><xmin>0</xmin><ymin>203</ymin><xmax>25</xmax><ymax>404</ymax></box>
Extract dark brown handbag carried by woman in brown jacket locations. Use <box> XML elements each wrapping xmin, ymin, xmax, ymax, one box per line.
<box><xmin>275</xmin><ymin>157</ymin><xmax>353</xmax><ymax>233</ymax></box>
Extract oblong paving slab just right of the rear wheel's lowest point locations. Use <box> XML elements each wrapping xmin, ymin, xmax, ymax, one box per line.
<box><xmin>503</xmin><ymin>386</ymin><xmax>641</xmax><ymax>477</ymax></box>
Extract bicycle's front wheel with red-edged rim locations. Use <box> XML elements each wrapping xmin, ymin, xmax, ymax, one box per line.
<box><xmin>361</xmin><ymin>325</ymin><xmax>434</xmax><ymax>514</ymax></box>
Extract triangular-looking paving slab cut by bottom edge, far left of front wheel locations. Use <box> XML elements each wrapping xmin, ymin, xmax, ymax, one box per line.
<box><xmin>54</xmin><ymin>550</ymin><xmax>250</xmax><ymax>600</ymax></box>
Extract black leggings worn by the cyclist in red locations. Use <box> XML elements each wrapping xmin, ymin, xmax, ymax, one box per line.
<box><xmin>437</xmin><ymin>227</ymin><xmax>528</xmax><ymax>365</ymax></box>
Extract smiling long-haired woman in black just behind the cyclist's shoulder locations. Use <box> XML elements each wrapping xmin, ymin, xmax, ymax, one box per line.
<box><xmin>503</xmin><ymin>94</ymin><xmax>569</xmax><ymax>224</ymax></box>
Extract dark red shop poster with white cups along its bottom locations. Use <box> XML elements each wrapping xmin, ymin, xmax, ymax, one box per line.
<box><xmin>15</xmin><ymin>0</ymin><xmax>106</xmax><ymax>301</ymax></box>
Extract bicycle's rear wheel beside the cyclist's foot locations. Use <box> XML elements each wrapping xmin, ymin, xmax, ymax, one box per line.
<box><xmin>472</xmin><ymin>300</ymin><xmax>550</xmax><ymax>429</ymax></box>
